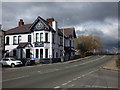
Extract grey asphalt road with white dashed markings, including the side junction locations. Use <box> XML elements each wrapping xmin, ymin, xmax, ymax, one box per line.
<box><xmin>2</xmin><ymin>56</ymin><xmax>118</xmax><ymax>88</ymax></box>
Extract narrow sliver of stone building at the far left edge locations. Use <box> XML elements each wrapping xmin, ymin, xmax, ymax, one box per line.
<box><xmin>0</xmin><ymin>25</ymin><xmax>4</xmax><ymax>59</ymax></box>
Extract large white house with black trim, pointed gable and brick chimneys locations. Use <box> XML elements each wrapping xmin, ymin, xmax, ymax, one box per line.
<box><xmin>5</xmin><ymin>16</ymin><xmax>76</xmax><ymax>60</ymax></box>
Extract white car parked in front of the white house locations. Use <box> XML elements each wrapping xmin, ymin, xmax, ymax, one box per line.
<box><xmin>0</xmin><ymin>58</ymin><xmax>22</xmax><ymax>67</ymax></box>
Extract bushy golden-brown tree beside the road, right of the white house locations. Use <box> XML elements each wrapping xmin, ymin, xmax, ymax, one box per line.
<box><xmin>75</xmin><ymin>35</ymin><xmax>103</xmax><ymax>55</ymax></box>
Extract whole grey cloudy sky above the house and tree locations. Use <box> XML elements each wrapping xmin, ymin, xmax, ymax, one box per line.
<box><xmin>2</xmin><ymin>2</ymin><xmax>118</xmax><ymax>50</ymax></box>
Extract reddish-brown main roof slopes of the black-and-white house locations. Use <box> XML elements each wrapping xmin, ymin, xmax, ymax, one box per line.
<box><xmin>5</xmin><ymin>16</ymin><xmax>76</xmax><ymax>37</ymax></box>
